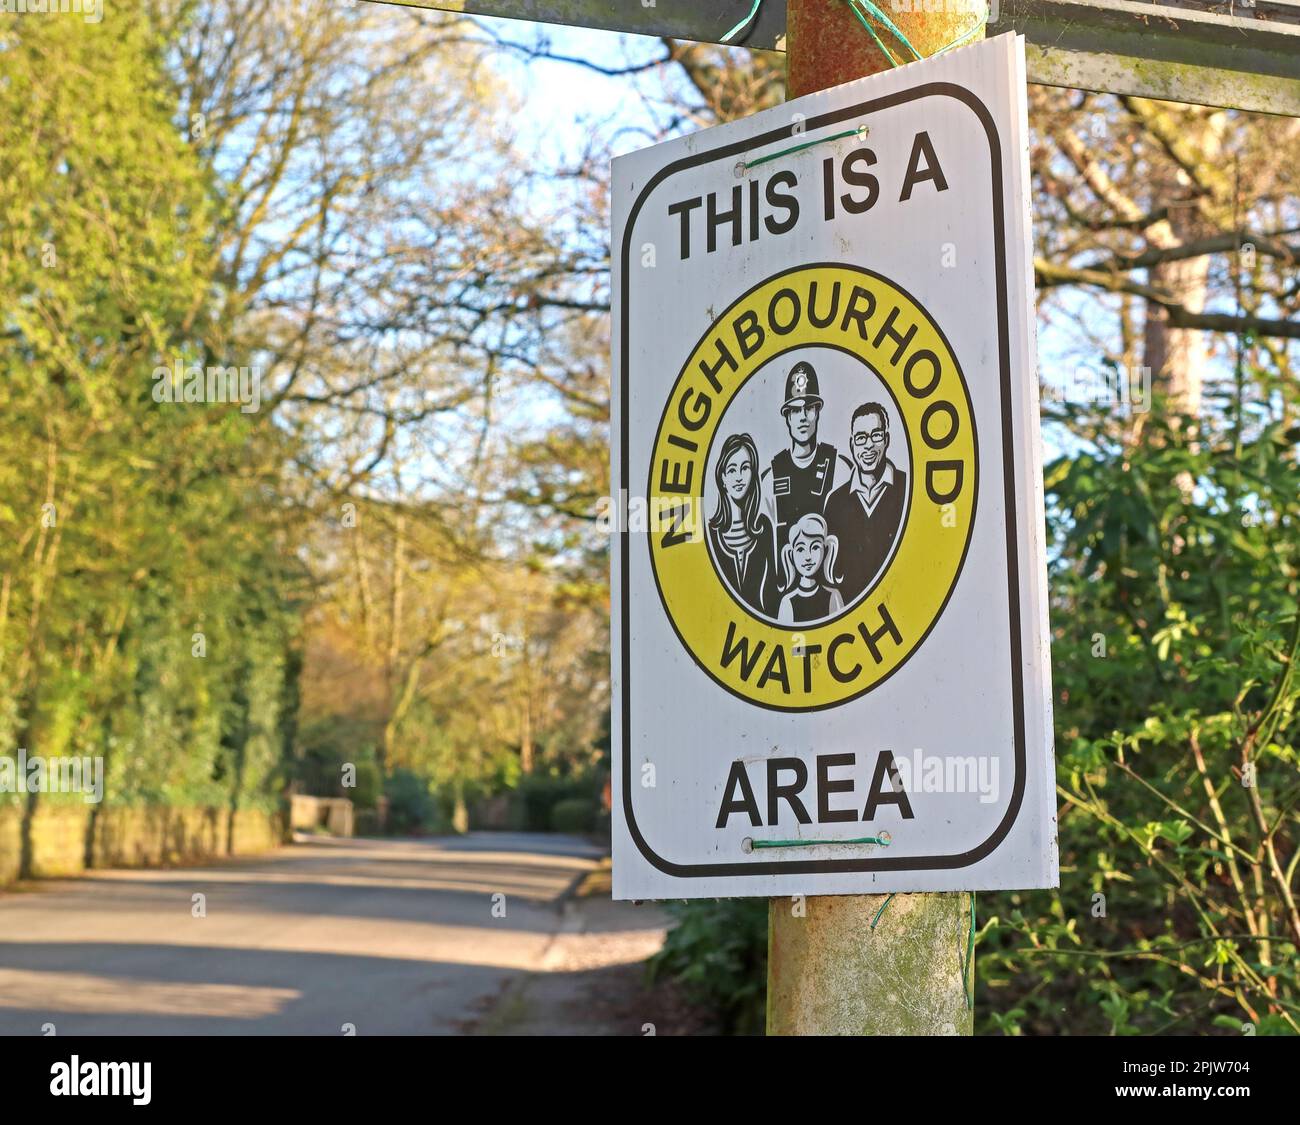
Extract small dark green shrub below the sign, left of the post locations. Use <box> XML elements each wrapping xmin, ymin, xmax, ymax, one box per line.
<box><xmin>649</xmin><ymin>899</ymin><xmax>767</xmax><ymax>1035</ymax></box>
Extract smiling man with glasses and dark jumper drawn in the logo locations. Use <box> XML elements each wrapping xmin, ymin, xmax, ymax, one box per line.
<box><xmin>826</xmin><ymin>402</ymin><xmax>907</xmax><ymax>606</ymax></box>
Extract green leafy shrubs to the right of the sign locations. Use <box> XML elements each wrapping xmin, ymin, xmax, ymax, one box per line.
<box><xmin>978</xmin><ymin>397</ymin><xmax>1300</xmax><ymax>1035</ymax></box>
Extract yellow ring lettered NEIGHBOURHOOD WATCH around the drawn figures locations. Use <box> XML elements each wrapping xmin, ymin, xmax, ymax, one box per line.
<box><xmin>646</xmin><ymin>265</ymin><xmax>992</xmax><ymax>711</ymax></box>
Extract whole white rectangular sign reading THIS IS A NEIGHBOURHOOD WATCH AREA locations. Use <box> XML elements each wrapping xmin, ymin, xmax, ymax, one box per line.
<box><xmin>611</xmin><ymin>35</ymin><xmax>1057</xmax><ymax>899</ymax></box>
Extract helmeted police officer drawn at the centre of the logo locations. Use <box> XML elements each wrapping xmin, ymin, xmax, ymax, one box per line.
<box><xmin>762</xmin><ymin>360</ymin><xmax>853</xmax><ymax>583</ymax></box>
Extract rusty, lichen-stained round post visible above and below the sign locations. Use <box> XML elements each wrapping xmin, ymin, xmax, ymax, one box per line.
<box><xmin>767</xmin><ymin>0</ymin><xmax>984</xmax><ymax>1035</ymax></box>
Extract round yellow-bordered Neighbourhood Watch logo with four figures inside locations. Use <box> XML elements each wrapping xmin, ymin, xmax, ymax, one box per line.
<box><xmin>646</xmin><ymin>264</ymin><xmax>978</xmax><ymax>711</ymax></box>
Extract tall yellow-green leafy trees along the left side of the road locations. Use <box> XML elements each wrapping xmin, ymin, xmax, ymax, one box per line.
<box><xmin>0</xmin><ymin>5</ymin><xmax>300</xmax><ymax>827</ymax></box>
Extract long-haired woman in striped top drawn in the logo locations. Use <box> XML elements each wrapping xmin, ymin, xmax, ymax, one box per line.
<box><xmin>709</xmin><ymin>433</ymin><xmax>776</xmax><ymax>616</ymax></box>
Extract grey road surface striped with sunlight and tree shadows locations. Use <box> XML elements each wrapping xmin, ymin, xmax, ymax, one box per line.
<box><xmin>0</xmin><ymin>832</ymin><xmax>663</xmax><ymax>1035</ymax></box>
